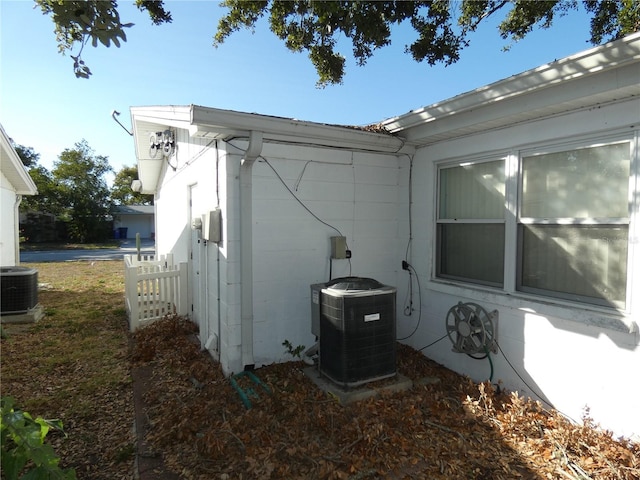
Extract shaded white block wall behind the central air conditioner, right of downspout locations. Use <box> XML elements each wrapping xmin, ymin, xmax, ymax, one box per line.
<box><xmin>248</xmin><ymin>144</ymin><xmax>408</xmax><ymax>364</ymax></box>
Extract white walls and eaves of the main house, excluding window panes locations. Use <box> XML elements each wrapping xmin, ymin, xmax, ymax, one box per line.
<box><xmin>138</xmin><ymin>34</ymin><xmax>640</xmax><ymax>444</ymax></box>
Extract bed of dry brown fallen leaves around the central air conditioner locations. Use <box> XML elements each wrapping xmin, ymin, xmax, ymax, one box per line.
<box><xmin>131</xmin><ymin>317</ymin><xmax>640</xmax><ymax>480</ymax></box>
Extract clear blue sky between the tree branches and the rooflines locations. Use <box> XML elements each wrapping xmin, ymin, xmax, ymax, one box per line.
<box><xmin>0</xmin><ymin>0</ymin><xmax>591</xmax><ymax>183</ymax></box>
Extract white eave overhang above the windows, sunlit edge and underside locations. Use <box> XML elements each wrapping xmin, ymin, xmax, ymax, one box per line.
<box><xmin>381</xmin><ymin>33</ymin><xmax>640</xmax><ymax>145</ymax></box>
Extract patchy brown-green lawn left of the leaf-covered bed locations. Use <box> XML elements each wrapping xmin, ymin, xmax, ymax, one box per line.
<box><xmin>1</xmin><ymin>261</ymin><xmax>134</xmax><ymax>480</ymax></box>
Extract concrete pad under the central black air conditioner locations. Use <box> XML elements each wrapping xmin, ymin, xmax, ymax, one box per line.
<box><xmin>303</xmin><ymin>367</ymin><xmax>413</xmax><ymax>405</ymax></box>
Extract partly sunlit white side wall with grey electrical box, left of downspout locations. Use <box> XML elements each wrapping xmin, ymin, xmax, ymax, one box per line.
<box><xmin>155</xmin><ymin>130</ymin><xmax>241</xmax><ymax>372</ymax></box>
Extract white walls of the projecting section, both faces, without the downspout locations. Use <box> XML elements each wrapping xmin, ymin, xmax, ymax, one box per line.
<box><xmin>151</xmin><ymin>134</ymin><xmax>408</xmax><ymax>373</ymax></box>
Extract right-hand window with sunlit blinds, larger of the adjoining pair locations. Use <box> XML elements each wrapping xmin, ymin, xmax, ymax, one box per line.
<box><xmin>517</xmin><ymin>142</ymin><xmax>631</xmax><ymax>307</ymax></box>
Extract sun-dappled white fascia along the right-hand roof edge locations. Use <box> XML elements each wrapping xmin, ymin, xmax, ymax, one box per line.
<box><xmin>381</xmin><ymin>33</ymin><xmax>640</xmax><ymax>137</ymax></box>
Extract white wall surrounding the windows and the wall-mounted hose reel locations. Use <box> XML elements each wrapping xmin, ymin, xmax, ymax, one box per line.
<box><xmin>407</xmin><ymin>100</ymin><xmax>640</xmax><ymax>436</ymax></box>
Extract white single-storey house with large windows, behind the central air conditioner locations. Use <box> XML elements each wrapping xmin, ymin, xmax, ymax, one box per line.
<box><xmin>131</xmin><ymin>34</ymin><xmax>640</xmax><ymax>435</ymax></box>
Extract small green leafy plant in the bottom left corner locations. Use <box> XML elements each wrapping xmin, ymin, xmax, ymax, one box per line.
<box><xmin>0</xmin><ymin>397</ymin><xmax>76</xmax><ymax>480</ymax></box>
